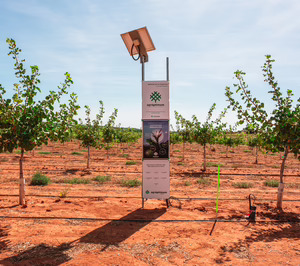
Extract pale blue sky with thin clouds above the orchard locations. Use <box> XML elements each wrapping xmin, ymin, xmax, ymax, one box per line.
<box><xmin>0</xmin><ymin>0</ymin><xmax>300</xmax><ymax>128</ymax></box>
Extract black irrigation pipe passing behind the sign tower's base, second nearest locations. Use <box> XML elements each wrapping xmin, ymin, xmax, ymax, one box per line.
<box><xmin>0</xmin><ymin>194</ymin><xmax>300</xmax><ymax>202</ymax></box>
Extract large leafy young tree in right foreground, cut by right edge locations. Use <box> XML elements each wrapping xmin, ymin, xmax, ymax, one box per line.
<box><xmin>225</xmin><ymin>55</ymin><xmax>300</xmax><ymax>209</ymax></box>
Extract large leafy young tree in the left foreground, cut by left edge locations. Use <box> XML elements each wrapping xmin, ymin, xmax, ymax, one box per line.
<box><xmin>0</xmin><ymin>39</ymin><xmax>79</xmax><ymax>205</ymax></box>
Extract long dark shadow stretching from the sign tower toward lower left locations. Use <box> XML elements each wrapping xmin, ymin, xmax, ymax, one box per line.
<box><xmin>0</xmin><ymin>209</ymin><xmax>166</xmax><ymax>266</ymax></box>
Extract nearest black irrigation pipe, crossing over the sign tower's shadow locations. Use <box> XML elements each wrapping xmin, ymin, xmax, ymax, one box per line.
<box><xmin>0</xmin><ymin>216</ymin><xmax>300</xmax><ymax>223</ymax></box>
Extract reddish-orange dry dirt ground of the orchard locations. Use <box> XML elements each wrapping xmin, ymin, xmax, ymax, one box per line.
<box><xmin>0</xmin><ymin>142</ymin><xmax>300</xmax><ymax>266</ymax></box>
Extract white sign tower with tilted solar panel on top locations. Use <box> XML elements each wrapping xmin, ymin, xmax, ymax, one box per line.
<box><xmin>121</xmin><ymin>27</ymin><xmax>170</xmax><ymax>208</ymax></box>
